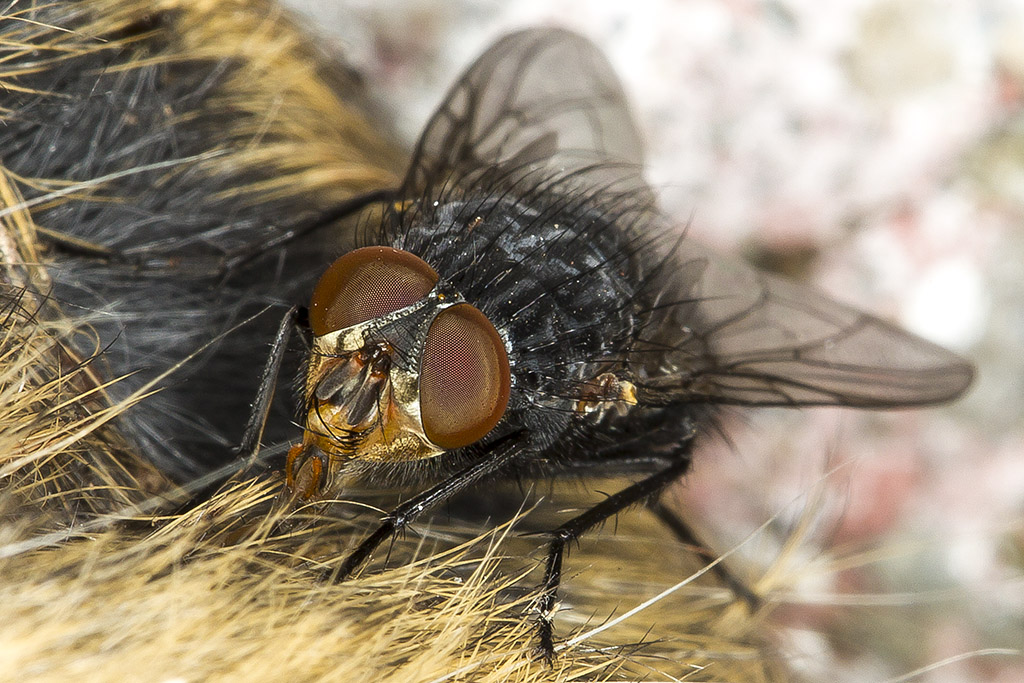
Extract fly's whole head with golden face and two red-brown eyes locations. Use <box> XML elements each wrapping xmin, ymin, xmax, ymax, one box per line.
<box><xmin>286</xmin><ymin>247</ymin><xmax>511</xmax><ymax>498</ymax></box>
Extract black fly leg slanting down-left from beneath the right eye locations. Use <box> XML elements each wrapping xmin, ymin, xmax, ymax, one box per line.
<box><xmin>333</xmin><ymin>432</ymin><xmax>521</xmax><ymax>581</ymax></box>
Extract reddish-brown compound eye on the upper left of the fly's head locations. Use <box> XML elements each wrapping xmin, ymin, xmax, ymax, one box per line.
<box><xmin>309</xmin><ymin>247</ymin><xmax>437</xmax><ymax>337</ymax></box>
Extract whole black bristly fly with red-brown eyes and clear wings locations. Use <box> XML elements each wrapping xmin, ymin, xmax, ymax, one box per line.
<box><xmin>228</xmin><ymin>30</ymin><xmax>973</xmax><ymax>655</ymax></box>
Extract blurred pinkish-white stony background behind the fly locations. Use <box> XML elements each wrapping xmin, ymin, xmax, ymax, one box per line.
<box><xmin>290</xmin><ymin>0</ymin><xmax>1024</xmax><ymax>681</ymax></box>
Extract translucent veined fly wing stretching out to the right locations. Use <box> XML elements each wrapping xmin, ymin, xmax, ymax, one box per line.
<box><xmin>637</xmin><ymin>240</ymin><xmax>974</xmax><ymax>408</ymax></box>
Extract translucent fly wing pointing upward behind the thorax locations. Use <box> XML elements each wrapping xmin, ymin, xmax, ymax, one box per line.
<box><xmin>402</xmin><ymin>29</ymin><xmax>646</xmax><ymax>198</ymax></box>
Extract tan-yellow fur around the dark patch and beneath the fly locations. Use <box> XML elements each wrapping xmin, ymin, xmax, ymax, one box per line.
<box><xmin>0</xmin><ymin>0</ymin><xmax>782</xmax><ymax>681</ymax></box>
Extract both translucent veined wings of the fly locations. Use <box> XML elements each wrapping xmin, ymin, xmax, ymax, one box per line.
<box><xmin>402</xmin><ymin>30</ymin><xmax>973</xmax><ymax>408</ymax></box>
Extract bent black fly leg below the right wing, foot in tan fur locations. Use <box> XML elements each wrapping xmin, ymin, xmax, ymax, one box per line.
<box><xmin>538</xmin><ymin>454</ymin><xmax>690</xmax><ymax>660</ymax></box>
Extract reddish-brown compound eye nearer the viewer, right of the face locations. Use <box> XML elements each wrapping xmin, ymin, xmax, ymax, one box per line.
<box><xmin>420</xmin><ymin>303</ymin><xmax>511</xmax><ymax>450</ymax></box>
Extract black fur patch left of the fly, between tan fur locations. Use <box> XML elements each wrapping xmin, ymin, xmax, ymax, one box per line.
<box><xmin>0</xmin><ymin>3</ymin><xmax>393</xmax><ymax>477</ymax></box>
